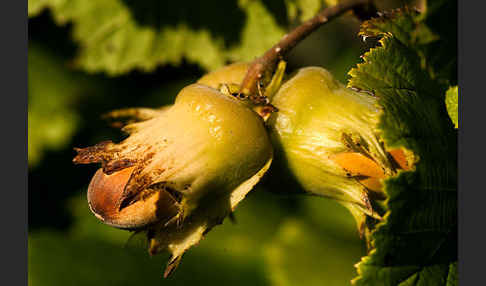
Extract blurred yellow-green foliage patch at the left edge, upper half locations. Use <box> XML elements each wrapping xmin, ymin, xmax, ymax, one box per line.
<box><xmin>28</xmin><ymin>43</ymin><xmax>80</xmax><ymax>166</ymax></box>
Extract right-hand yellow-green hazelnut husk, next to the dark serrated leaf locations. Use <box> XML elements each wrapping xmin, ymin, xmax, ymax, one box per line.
<box><xmin>268</xmin><ymin>67</ymin><xmax>389</xmax><ymax>215</ymax></box>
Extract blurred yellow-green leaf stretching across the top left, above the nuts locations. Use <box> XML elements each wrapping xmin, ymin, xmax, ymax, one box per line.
<box><xmin>28</xmin><ymin>0</ymin><xmax>284</xmax><ymax>75</ymax></box>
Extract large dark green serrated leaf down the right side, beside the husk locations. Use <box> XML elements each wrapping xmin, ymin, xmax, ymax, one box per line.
<box><xmin>348</xmin><ymin>6</ymin><xmax>457</xmax><ymax>285</ymax></box>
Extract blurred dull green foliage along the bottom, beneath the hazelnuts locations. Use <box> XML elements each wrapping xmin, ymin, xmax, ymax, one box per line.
<box><xmin>28</xmin><ymin>189</ymin><xmax>364</xmax><ymax>285</ymax></box>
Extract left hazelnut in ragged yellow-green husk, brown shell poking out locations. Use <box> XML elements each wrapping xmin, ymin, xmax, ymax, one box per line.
<box><xmin>74</xmin><ymin>81</ymin><xmax>273</xmax><ymax>275</ymax></box>
